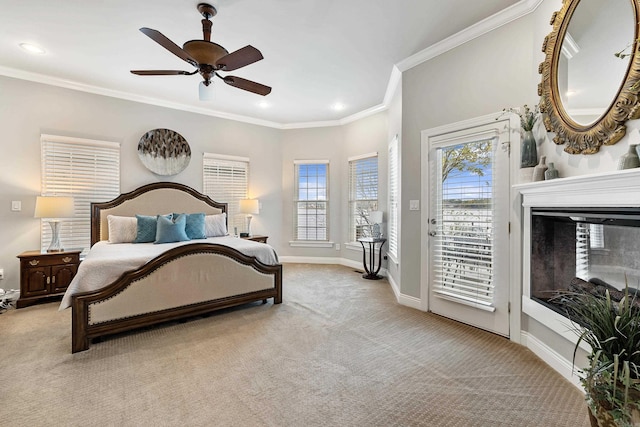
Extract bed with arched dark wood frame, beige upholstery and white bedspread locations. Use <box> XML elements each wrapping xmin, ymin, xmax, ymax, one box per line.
<box><xmin>60</xmin><ymin>182</ymin><xmax>282</xmax><ymax>353</ymax></box>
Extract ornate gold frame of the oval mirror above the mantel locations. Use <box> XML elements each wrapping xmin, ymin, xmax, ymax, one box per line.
<box><xmin>538</xmin><ymin>0</ymin><xmax>640</xmax><ymax>154</ymax></box>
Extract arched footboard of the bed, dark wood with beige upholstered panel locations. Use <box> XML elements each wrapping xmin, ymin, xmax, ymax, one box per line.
<box><xmin>71</xmin><ymin>243</ymin><xmax>282</xmax><ymax>353</ymax></box>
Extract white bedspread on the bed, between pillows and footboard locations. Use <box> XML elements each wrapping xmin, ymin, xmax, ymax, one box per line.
<box><xmin>59</xmin><ymin>236</ymin><xmax>278</xmax><ymax>310</ymax></box>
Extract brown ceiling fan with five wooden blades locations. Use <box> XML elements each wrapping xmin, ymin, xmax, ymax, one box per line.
<box><xmin>131</xmin><ymin>3</ymin><xmax>271</xmax><ymax>96</ymax></box>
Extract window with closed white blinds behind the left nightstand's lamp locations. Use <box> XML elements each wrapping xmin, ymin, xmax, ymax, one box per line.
<box><xmin>40</xmin><ymin>135</ymin><xmax>120</xmax><ymax>249</ymax></box>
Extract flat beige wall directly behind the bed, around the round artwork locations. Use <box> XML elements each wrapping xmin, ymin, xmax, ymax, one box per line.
<box><xmin>0</xmin><ymin>77</ymin><xmax>282</xmax><ymax>289</ymax></box>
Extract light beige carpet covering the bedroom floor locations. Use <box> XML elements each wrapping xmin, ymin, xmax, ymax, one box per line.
<box><xmin>0</xmin><ymin>264</ymin><xmax>589</xmax><ymax>427</ymax></box>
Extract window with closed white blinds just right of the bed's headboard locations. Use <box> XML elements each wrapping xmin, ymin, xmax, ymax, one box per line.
<box><xmin>202</xmin><ymin>153</ymin><xmax>249</xmax><ymax>232</ymax></box>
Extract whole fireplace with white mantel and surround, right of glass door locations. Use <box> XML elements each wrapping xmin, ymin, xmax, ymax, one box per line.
<box><xmin>514</xmin><ymin>168</ymin><xmax>640</xmax><ymax>343</ymax></box>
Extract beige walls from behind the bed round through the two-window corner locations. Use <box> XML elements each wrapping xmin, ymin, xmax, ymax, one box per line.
<box><xmin>0</xmin><ymin>77</ymin><xmax>387</xmax><ymax>289</ymax></box>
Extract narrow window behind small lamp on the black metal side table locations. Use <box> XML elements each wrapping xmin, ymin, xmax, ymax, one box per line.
<box><xmin>349</xmin><ymin>153</ymin><xmax>378</xmax><ymax>242</ymax></box>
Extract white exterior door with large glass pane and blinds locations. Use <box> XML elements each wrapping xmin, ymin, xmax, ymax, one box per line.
<box><xmin>423</xmin><ymin>120</ymin><xmax>510</xmax><ymax>336</ymax></box>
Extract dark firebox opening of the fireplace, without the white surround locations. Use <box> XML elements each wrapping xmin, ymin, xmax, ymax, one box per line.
<box><xmin>530</xmin><ymin>207</ymin><xmax>640</xmax><ymax>314</ymax></box>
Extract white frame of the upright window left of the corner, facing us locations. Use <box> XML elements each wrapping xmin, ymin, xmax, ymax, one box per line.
<box><xmin>289</xmin><ymin>160</ymin><xmax>333</xmax><ymax>247</ymax></box>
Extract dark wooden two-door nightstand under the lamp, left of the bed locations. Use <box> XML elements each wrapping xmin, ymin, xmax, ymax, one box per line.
<box><xmin>16</xmin><ymin>250</ymin><xmax>81</xmax><ymax>308</ymax></box>
